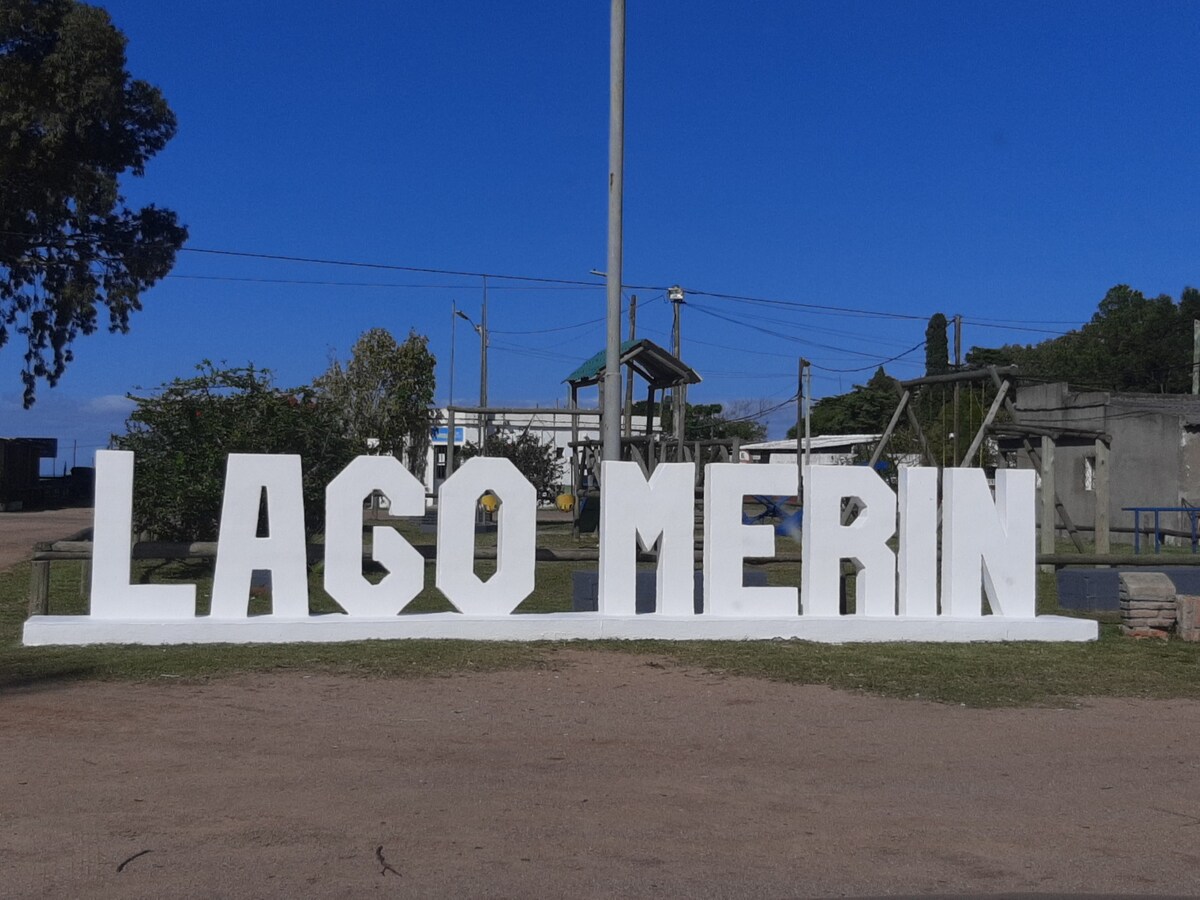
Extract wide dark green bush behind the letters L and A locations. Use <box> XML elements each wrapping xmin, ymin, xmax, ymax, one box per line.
<box><xmin>113</xmin><ymin>361</ymin><xmax>355</xmax><ymax>541</ymax></box>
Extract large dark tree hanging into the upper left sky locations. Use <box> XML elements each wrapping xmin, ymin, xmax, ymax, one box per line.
<box><xmin>0</xmin><ymin>0</ymin><xmax>187</xmax><ymax>408</ymax></box>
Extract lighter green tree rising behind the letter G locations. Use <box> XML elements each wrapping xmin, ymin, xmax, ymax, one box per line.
<box><xmin>313</xmin><ymin>328</ymin><xmax>437</xmax><ymax>478</ymax></box>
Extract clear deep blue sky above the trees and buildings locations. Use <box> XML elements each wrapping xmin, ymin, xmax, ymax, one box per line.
<box><xmin>0</xmin><ymin>0</ymin><xmax>1200</xmax><ymax>464</ymax></box>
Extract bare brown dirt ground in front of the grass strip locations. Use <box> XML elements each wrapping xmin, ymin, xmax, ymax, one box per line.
<box><xmin>0</xmin><ymin>649</ymin><xmax>1200</xmax><ymax>898</ymax></box>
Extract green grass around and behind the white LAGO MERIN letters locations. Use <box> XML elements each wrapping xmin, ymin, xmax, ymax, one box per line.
<box><xmin>0</xmin><ymin>523</ymin><xmax>1200</xmax><ymax>707</ymax></box>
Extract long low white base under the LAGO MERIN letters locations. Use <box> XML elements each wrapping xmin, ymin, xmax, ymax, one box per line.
<box><xmin>23</xmin><ymin>612</ymin><xmax>1099</xmax><ymax>647</ymax></box>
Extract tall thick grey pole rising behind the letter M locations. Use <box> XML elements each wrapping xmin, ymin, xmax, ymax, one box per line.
<box><xmin>601</xmin><ymin>0</ymin><xmax>625</xmax><ymax>460</ymax></box>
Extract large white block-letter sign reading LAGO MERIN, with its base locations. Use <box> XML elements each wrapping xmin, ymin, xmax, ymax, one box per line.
<box><xmin>23</xmin><ymin>451</ymin><xmax>1099</xmax><ymax>644</ymax></box>
